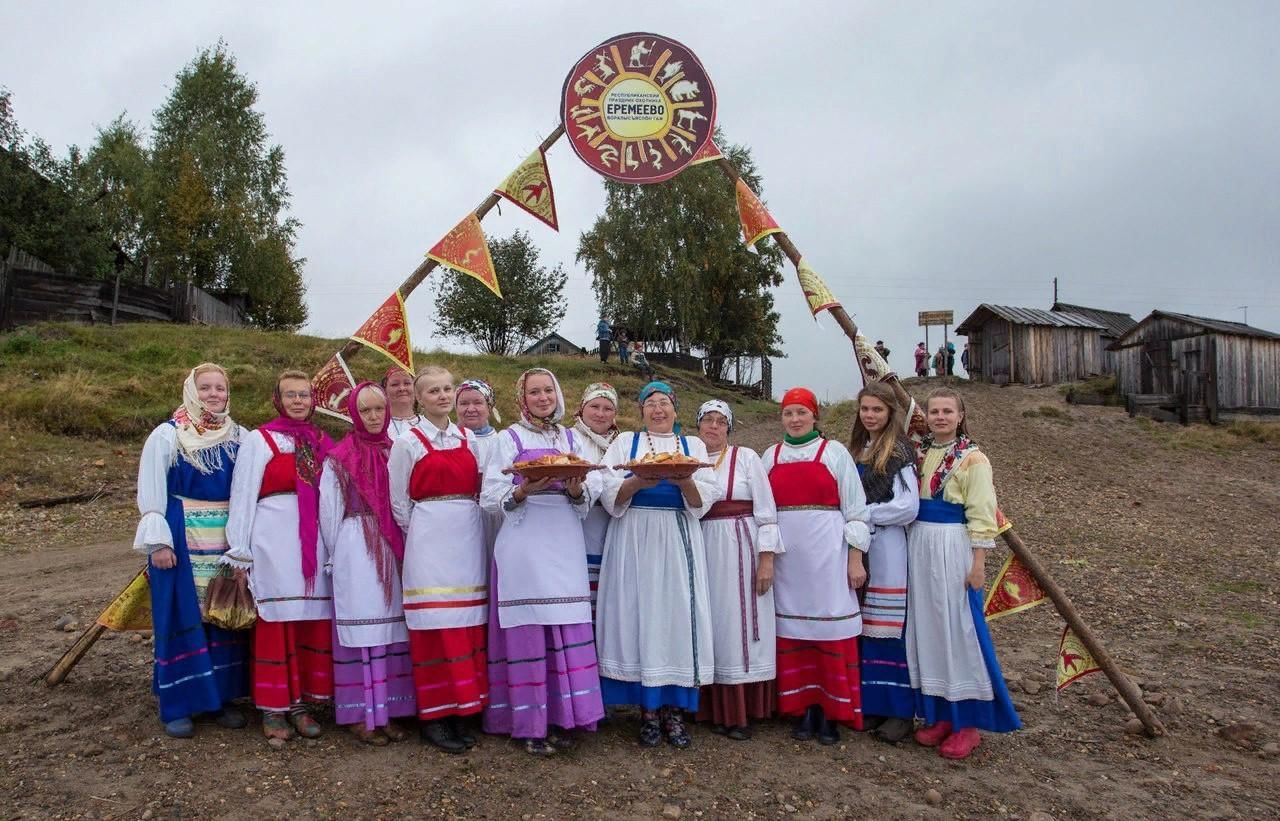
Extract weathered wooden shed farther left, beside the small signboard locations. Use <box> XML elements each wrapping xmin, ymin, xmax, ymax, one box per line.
<box><xmin>956</xmin><ymin>302</ymin><xmax>1105</xmax><ymax>384</ymax></box>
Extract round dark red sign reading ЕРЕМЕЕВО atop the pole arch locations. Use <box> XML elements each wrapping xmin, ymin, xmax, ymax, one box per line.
<box><xmin>561</xmin><ymin>32</ymin><xmax>716</xmax><ymax>183</ymax></box>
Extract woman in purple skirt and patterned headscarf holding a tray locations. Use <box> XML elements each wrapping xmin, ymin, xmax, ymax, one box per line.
<box><xmin>481</xmin><ymin>368</ymin><xmax>604</xmax><ymax>756</ymax></box>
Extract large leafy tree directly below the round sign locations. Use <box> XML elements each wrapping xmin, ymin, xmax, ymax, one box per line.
<box><xmin>577</xmin><ymin>129</ymin><xmax>783</xmax><ymax>378</ymax></box>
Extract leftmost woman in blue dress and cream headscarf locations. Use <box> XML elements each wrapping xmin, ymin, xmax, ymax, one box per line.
<box><xmin>133</xmin><ymin>362</ymin><xmax>248</xmax><ymax>738</ymax></box>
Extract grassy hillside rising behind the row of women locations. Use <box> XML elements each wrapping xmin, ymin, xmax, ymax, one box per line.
<box><xmin>0</xmin><ymin>323</ymin><xmax>777</xmax><ymax>441</ymax></box>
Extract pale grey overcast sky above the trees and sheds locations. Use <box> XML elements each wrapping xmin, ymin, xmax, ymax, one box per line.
<box><xmin>0</xmin><ymin>0</ymin><xmax>1280</xmax><ymax>400</ymax></box>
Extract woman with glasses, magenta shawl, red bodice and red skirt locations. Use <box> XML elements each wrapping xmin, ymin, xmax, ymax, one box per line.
<box><xmin>223</xmin><ymin>370</ymin><xmax>333</xmax><ymax>739</ymax></box>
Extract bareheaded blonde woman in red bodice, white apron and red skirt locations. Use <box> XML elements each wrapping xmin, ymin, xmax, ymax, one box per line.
<box><xmin>388</xmin><ymin>365</ymin><xmax>489</xmax><ymax>753</ymax></box>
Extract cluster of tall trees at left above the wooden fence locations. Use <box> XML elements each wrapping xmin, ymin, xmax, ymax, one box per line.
<box><xmin>0</xmin><ymin>42</ymin><xmax>307</xmax><ymax>329</ymax></box>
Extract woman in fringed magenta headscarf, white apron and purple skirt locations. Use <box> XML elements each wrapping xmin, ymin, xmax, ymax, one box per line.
<box><xmin>320</xmin><ymin>382</ymin><xmax>415</xmax><ymax>747</ymax></box>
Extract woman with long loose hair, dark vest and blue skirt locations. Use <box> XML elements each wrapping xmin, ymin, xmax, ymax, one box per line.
<box><xmin>849</xmin><ymin>382</ymin><xmax>920</xmax><ymax>742</ymax></box>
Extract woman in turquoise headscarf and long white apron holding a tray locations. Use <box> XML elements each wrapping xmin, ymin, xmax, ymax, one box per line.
<box><xmin>595</xmin><ymin>382</ymin><xmax>718</xmax><ymax>748</ymax></box>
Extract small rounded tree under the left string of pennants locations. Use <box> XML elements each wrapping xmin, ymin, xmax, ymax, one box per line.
<box><xmin>435</xmin><ymin>231</ymin><xmax>566</xmax><ymax>356</ymax></box>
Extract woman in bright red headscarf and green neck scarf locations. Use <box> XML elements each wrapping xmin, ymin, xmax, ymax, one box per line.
<box><xmin>763</xmin><ymin>388</ymin><xmax>870</xmax><ymax>744</ymax></box>
